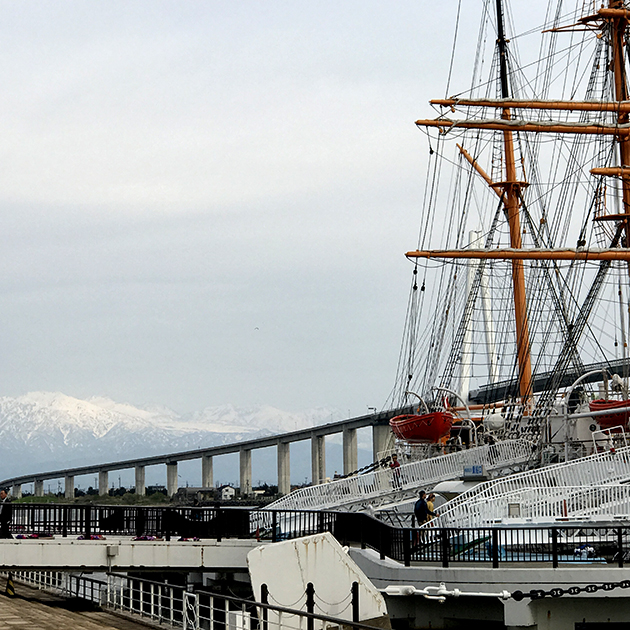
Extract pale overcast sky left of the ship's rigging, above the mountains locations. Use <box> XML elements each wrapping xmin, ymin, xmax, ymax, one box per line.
<box><xmin>0</xmin><ymin>0</ymin><xmax>552</xmax><ymax>415</ymax></box>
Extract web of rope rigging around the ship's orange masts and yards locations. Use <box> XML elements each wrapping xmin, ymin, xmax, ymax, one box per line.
<box><xmin>392</xmin><ymin>0</ymin><xmax>630</xmax><ymax>436</ymax></box>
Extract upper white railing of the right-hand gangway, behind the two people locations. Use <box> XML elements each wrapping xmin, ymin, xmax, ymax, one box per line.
<box><xmin>434</xmin><ymin>447</ymin><xmax>630</xmax><ymax>527</ymax></box>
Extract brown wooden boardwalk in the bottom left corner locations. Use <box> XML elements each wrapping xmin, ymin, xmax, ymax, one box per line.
<box><xmin>0</xmin><ymin>578</ymin><xmax>147</xmax><ymax>630</ymax></box>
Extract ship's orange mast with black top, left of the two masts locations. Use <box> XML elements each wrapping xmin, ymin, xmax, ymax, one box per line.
<box><xmin>496</xmin><ymin>0</ymin><xmax>532</xmax><ymax>404</ymax></box>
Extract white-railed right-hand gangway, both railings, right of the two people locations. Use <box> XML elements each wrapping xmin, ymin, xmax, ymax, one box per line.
<box><xmin>432</xmin><ymin>447</ymin><xmax>630</xmax><ymax>527</ymax></box>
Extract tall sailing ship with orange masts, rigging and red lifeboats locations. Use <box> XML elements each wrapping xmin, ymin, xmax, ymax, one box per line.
<box><xmin>391</xmin><ymin>0</ymin><xmax>630</xmax><ymax>461</ymax></box>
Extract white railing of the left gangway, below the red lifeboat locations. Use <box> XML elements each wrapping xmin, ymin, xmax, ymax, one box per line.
<box><xmin>266</xmin><ymin>440</ymin><xmax>532</xmax><ymax>510</ymax></box>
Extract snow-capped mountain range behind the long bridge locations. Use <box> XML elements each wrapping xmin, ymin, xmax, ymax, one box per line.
<box><xmin>0</xmin><ymin>392</ymin><xmax>341</xmax><ymax>479</ymax></box>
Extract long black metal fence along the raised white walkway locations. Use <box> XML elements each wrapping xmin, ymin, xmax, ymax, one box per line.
<box><xmin>6</xmin><ymin>504</ymin><xmax>630</xmax><ymax>567</ymax></box>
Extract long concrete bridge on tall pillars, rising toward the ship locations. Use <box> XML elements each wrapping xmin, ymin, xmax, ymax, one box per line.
<box><xmin>0</xmin><ymin>409</ymin><xmax>400</xmax><ymax>499</ymax></box>
